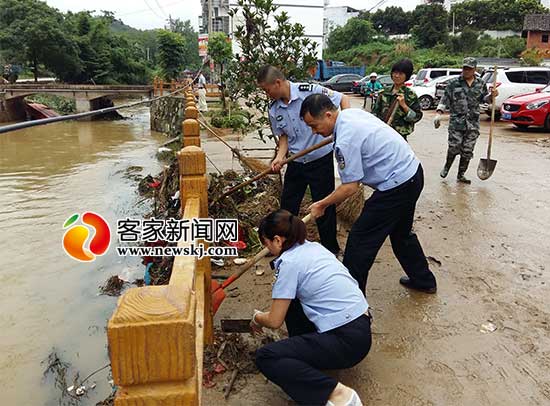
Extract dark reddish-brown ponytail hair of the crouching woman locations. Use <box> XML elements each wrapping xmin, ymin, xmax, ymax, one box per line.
<box><xmin>258</xmin><ymin>209</ymin><xmax>307</xmax><ymax>254</ymax></box>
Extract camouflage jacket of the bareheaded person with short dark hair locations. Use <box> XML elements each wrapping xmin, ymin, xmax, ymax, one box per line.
<box><xmin>372</xmin><ymin>85</ymin><xmax>422</xmax><ymax>139</ymax></box>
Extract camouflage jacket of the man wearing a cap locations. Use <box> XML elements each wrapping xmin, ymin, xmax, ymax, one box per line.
<box><xmin>437</xmin><ymin>76</ymin><xmax>490</xmax><ymax>131</ymax></box>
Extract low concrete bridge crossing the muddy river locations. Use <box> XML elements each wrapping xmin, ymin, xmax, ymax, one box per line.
<box><xmin>0</xmin><ymin>83</ymin><xmax>153</xmax><ymax>122</ymax></box>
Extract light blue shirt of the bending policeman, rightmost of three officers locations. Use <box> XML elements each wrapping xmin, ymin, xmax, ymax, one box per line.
<box><xmin>334</xmin><ymin>109</ymin><xmax>420</xmax><ymax>191</ymax></box>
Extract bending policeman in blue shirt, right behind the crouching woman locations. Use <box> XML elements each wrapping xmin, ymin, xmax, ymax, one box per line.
<box><xmin>300</xmin><ymin>95</ymin><xmax>436</xmax><ymax>293</ymax></box>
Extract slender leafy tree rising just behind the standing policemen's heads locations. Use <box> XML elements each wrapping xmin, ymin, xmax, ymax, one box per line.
<box><xmin>225</xmin><ymin>0</ymin><xmax>317</xmax><ymax>139</ymax></box>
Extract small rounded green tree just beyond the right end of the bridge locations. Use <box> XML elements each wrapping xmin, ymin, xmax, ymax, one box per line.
<box><xmin>158</xmin><ymin>30</ymin><xmax>185</xmax><ymax>80</ymax></box>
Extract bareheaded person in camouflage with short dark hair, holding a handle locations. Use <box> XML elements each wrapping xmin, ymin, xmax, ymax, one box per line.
<box><xmin>372</xmin><ymin>59</ymin><xmax>422</xmax><ymax>141</ymax></box>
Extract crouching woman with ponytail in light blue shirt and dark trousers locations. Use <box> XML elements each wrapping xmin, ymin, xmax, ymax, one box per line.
<box><xmin>251</xmin><ymin>210</ymin><xmax>371</xmax><ymax>406</ymax></box>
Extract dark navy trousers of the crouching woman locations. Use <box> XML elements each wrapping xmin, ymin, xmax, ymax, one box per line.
<box><xmin>256</xmin><ymin>310</ymin><xmax>371</xmax><ymax>406</ymax></box>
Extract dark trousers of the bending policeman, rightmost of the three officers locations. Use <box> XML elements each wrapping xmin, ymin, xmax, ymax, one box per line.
<box><xmin>343</xmin><ymin>165</ymin><xmax>436</xmax><ymax>292</ymax></box>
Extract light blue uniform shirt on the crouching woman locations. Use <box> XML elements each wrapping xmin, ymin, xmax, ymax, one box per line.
<box><xmin>272</xmin><ymin>240</ymin><xmax>369</xmax><ymax>333</ymax></box>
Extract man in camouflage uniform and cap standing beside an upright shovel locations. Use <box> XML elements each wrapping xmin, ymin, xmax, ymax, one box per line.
<box><xmin>434</xmin><ymin>57</ymin><xmax>498</xmax><ymax>184</ymax></box>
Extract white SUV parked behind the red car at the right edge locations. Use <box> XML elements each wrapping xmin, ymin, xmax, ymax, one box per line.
<box><xmin>481</xmin><ymin>67</ymin><xmax>550</xmax><ymax>116</ymax></box>
